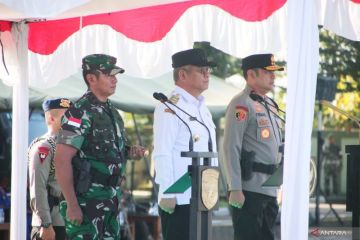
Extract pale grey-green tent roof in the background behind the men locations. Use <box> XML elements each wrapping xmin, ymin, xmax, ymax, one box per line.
<box><xmin>0</xmin><ymin>72</ymin><xmax>240</xmax><ymax>120</ymax></box>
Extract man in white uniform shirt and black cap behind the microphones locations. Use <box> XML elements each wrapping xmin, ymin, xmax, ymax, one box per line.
<box><xmin>153</xmin><ymin>49</ymin><xmax>217</xmax><ymax>240</ymax></box>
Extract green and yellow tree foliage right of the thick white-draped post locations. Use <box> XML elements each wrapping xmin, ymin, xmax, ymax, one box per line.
<box><xmin>315</xmin><ymin>28</ymin><xmax>360</xmax><ymax>130</ymax></box>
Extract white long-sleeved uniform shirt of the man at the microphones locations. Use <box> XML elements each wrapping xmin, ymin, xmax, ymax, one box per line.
<box><xmin>153</xmin><ymin>86</ymin><xmax>218</xmax><ymax>205</ymax></box>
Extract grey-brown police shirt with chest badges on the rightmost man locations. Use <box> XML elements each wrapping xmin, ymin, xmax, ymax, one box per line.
<box><xmin>223</xmin><ymin>85</ymin><xmax>282</xmax><ymax>196</ymax></box>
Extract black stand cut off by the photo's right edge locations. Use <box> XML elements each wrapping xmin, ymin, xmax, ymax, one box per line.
<box><xmin>345</xmin><ymin>145</ymin><xmax>360</xmax><ymax>239</ymax></box>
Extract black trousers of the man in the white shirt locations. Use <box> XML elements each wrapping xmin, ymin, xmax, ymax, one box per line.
<box><xmin>159</xmin><ymin>204</ymin><xmax>190</xmax><ymax>240</ymax></box>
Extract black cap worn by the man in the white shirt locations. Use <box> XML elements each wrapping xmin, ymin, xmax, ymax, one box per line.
<box><xmin>171</xmin><ymin>48</ymin><xmax>216</xmax><ymax>68</ymax></box>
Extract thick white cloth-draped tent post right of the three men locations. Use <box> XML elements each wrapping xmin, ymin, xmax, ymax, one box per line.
<box><xmin>281</xmin><ymin>0</ymin><xmax>319</xmax><ymax>240</ymax></box>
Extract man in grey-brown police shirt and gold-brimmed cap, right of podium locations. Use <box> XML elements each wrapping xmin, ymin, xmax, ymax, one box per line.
<box><xmin>223</xmin><ymin>54</ymin><xmax>284</xmax><ymax>240</ymax></box>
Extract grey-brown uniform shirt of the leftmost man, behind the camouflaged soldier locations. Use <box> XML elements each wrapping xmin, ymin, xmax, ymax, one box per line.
<box><xmin>28</xmin><ymin>134</ymin><xmax>64</xmax><ymax>226</ymax></box>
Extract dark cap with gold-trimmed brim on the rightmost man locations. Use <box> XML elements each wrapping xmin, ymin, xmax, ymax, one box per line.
<box><xmin>242</xmin><ymin>53</ymin><xmax>284</xmax><ymax>71</ymax></box>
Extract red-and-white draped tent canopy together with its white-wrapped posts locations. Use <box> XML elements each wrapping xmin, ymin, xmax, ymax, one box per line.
<box><xmin>0</xmin><ymin>0</ymin><xmax>360</xmax><ymax>240</ymax></box>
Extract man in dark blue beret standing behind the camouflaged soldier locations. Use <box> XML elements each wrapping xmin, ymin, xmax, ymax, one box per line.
<box><xmin>28</xmin><ymin>98</ymin><xmax>70</xmax><ymax>240</ymax></box>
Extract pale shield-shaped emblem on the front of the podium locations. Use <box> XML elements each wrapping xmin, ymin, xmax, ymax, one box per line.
<box><xmin>201</xmin><ymin>168</ymin><xmax>220</xmax><ymax>210</ymax></box>
